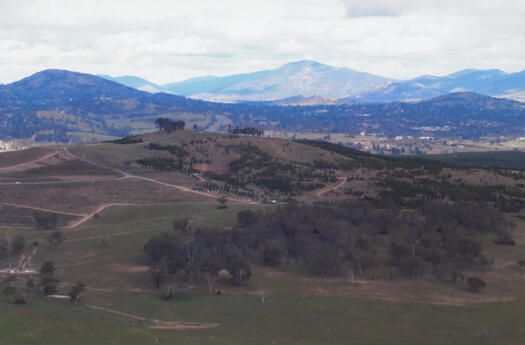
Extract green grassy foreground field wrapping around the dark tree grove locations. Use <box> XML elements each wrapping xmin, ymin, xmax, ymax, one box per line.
<box><xmin>0</xmin><ymin>203</ymin><xmax>525</xmax><ymax>345</ymax></box>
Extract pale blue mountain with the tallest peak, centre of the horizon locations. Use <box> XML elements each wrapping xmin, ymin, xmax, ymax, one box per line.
<box><xmin>101</xmin><ymin>60</ymin><xmax>392</xmax><ymax>102</ymax></box>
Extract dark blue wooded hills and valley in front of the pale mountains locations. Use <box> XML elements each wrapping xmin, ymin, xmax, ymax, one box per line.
<box><xmin>0</xmin><ymin>70</ymin><xmax>525</xmax><ymax>142</ymax></box>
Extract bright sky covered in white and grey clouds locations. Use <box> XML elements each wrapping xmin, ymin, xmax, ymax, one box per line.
<box><xmin>0</xmin><ymin>0</ymin><xmax>525</xmax><ymax>84</ymax></box>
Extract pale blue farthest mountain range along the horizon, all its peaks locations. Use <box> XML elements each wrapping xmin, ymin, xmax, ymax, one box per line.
<box><xmin>102</xmin><ymin>60</ymin><xmax>525</xmax><ymax>105</ymax></box>
